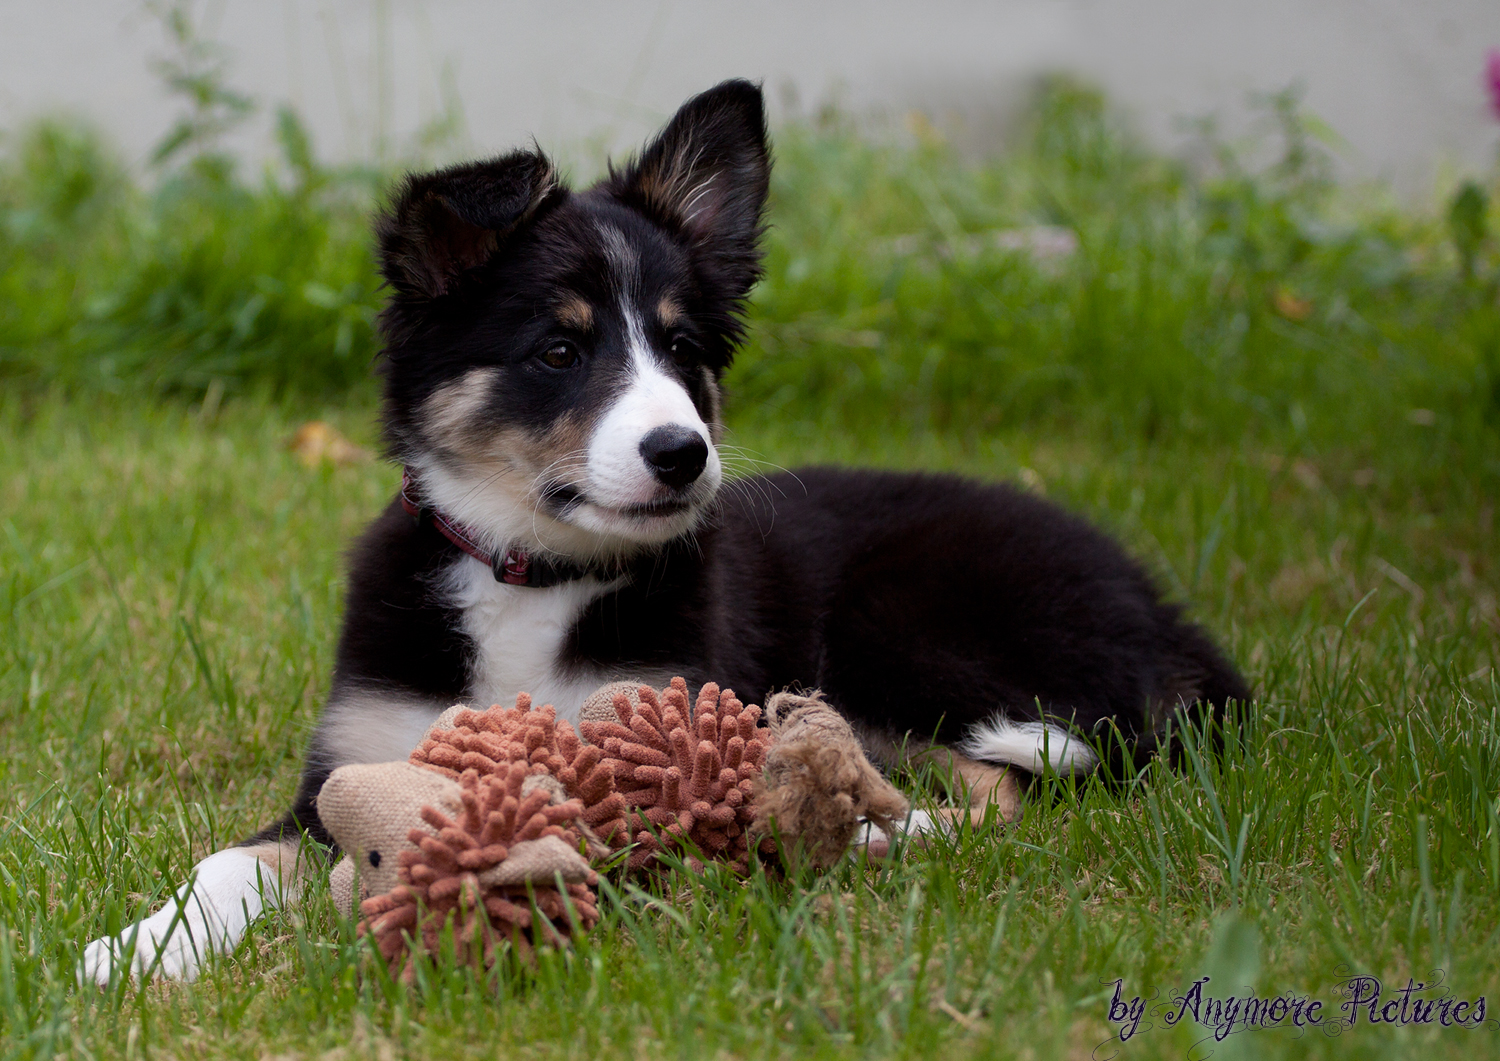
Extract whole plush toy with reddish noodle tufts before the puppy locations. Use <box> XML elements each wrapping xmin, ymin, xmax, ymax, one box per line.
<box><xmin>318</xmin><ymin>678</ymin><xmax>906</xmax><ymax>978</ymax></box>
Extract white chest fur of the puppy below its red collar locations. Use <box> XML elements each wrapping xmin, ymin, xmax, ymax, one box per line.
<box><xmin>449</xmin><ymin>557</ymin><xmax>609</xmax><ymax>722</ymax></box>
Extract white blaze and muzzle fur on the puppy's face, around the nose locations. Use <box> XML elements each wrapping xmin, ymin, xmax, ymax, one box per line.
<box><xmin>585</xmin><ymin>306</ymin><xmax>723</xmax><ymax>522</ymax></box>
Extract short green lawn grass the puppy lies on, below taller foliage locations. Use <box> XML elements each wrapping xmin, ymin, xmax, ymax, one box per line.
<box><xmin>0</xmin><ymin>384</ymin><xmax>1500</xmax><ymax>1058</ymax></box>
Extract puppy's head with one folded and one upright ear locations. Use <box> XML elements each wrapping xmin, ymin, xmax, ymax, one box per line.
<box><xmin>377</xmin><ymin>81</ymin><xmax>770</xmax><ymax>558</ymax></box>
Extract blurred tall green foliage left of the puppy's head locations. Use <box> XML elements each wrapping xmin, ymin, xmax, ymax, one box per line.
<box><xmin>0</xmin><ymin>111</ymin><xmax>378</xmax><ymax>396</ymax></box>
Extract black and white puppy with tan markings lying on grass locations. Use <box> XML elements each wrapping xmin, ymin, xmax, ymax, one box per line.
<box><xmin>81</xmin><ymin>81</ymin><xmax>1248</xmax><ymax>983</ymax></box>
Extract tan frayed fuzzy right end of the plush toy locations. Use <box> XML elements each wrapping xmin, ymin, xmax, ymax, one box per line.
<box><xmin>753</xmin><ymin>692</ymin><xmax>908</xmax><ymax>869</ymax></box>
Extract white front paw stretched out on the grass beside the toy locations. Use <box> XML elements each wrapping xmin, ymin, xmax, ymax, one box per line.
<box><xmin>78</xmin><ymin>848</ymin><xmax>281</xmax><ymax>986</ymax></box>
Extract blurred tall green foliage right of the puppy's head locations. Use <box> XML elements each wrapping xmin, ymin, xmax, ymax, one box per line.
<box><xmin>734</xmin><ymin>83</ymin><xmax>1500</xmax><ymax>453</ymax></box>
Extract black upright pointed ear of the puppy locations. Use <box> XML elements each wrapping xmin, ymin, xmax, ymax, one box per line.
<box><xmin>609</xmin><ymin>81</ymin><xmax>771</xmax><ymax>296</ymax></box>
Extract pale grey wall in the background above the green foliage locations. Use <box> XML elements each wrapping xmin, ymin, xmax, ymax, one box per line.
<box><xmin>0</xmin><ymin>0</ymin><xmax>1500</xmax><ymax>195</ymax></box>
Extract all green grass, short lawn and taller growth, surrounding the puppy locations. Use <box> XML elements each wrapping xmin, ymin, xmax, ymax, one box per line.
<box><xmin>0</xmin><ymin>86</ymin><xmax>1500</xmax><ymax>1058</ymax></box>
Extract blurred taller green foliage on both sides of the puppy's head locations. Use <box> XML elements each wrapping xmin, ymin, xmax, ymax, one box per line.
<box><xmin>0</xmin><ymin>81</ymin><xmax>1500</xmax><ymax>453</ymax></box>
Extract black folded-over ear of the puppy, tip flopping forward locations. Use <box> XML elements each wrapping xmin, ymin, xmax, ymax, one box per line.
<box><xmin>375</xmin><ymin>152</ymin><xmax>564</xmax><ymax>299</ymax></box>
